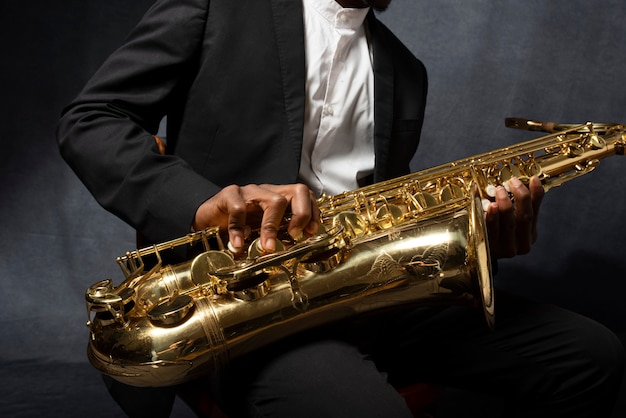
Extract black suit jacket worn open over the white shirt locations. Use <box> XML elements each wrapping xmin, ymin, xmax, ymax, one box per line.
<box><xmin>58</xmin><ymin>0</ymin><xmax>427</xmax><ymax>242</ymax></box>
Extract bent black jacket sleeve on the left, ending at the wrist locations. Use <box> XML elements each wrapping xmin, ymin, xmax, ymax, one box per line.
<box><xmin>57</xmin><ymin>0</ymin><xmax>219</xmax><ymax>242</ymax></box>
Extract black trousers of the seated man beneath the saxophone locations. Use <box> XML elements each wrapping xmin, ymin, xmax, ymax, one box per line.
<box><xmin>105</xmin><ymin>292</ymin><xmax>624</xmax><ymax>418</ymax></box>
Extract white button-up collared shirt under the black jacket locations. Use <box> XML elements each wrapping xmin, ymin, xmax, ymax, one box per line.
<box><xmin>299</xmin><ymin>0</ymin><xmax>374</xmax><ymax>195</ymax></box>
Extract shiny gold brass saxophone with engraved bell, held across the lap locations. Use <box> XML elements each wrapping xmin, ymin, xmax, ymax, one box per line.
<box><xmin>85</xmin><ymin>118</ymin><xmax>626</xmax><ymax>386</ymax></box>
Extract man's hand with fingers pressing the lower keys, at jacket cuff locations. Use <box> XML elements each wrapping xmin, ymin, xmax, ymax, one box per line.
<box><xmin>192</xmin><ymin>184</ymin><xmax>320</xmax><ymax>252</ymax></box>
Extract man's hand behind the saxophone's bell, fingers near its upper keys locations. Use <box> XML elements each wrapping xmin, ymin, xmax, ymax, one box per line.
<box><xmin>485</xmin><ymin>176</ymin><xmax>544</xmax><ymax>259</ymax></box>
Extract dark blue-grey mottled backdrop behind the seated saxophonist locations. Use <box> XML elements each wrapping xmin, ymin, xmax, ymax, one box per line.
<box><xmin>0</xmin><ymin>0</ymin><xmax>626</xmax><ymax>416</ymax></box>
